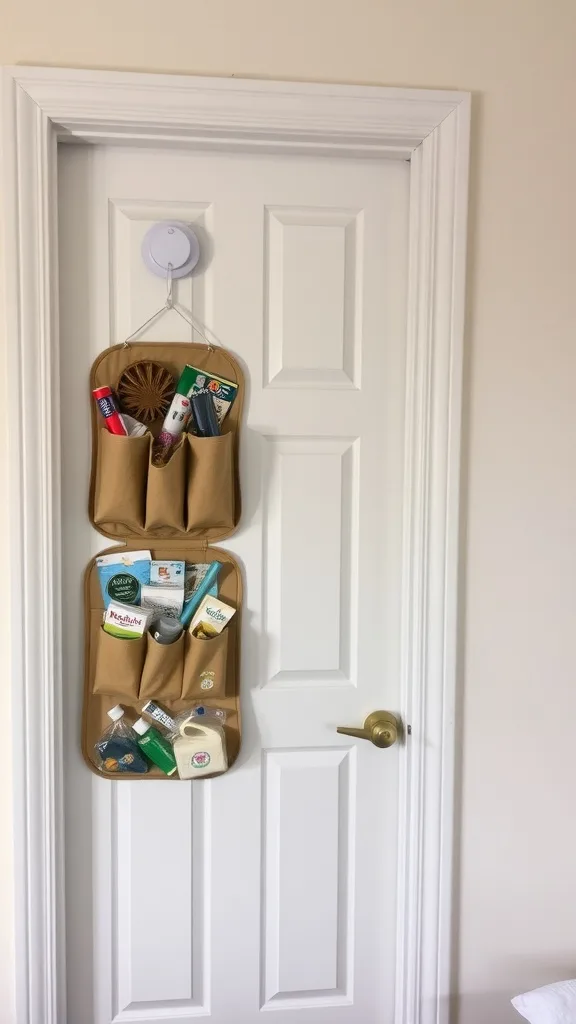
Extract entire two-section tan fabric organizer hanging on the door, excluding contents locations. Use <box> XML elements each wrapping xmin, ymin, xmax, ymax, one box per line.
<box><xmin>82</xmin><ymin>342</ymin><xmax>244</xmax><ymax>780</ymax></box>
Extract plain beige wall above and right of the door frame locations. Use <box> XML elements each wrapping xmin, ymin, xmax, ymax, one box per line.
<box><xmin>0</xmin><ymin>0</ymin><xmax>576</xmax><ymax>1024</ymax></box>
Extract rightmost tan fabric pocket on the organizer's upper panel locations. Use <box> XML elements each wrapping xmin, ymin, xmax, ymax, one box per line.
<box><xmin>187</xmin><ymin>433</ymin><xmax>235</xmax><ymax>530</ymax></box>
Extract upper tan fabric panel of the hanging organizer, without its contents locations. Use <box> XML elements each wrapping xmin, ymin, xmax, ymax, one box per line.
<box><xmin>89</xmin><ymin>342</ymin><xmax>244</xmax><ymax>543</ymax></box>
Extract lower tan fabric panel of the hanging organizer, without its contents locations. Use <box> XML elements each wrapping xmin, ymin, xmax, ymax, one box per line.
<box><xmin>82</xmin><ymin>542</ymin><xmax>242</xmax><ymax>781</ymax></box>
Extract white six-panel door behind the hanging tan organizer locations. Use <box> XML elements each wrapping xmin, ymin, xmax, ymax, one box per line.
<box><xmin>59</xmin><ymin>145</ymin><xmax>409</xmax><ymax>1024</ymax></box>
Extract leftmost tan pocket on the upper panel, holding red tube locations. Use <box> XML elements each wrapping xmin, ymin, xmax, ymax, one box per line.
<box><xmin>94</xmin><ymin>428</ymin><xmax>151</xmax><ymax>530</ymax></box>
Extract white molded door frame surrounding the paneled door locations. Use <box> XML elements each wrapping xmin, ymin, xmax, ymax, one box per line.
<box><xmin>0</xmin><ymin>68</ymin><xmax>469</xmax><ymax>1024</ymax></box>
